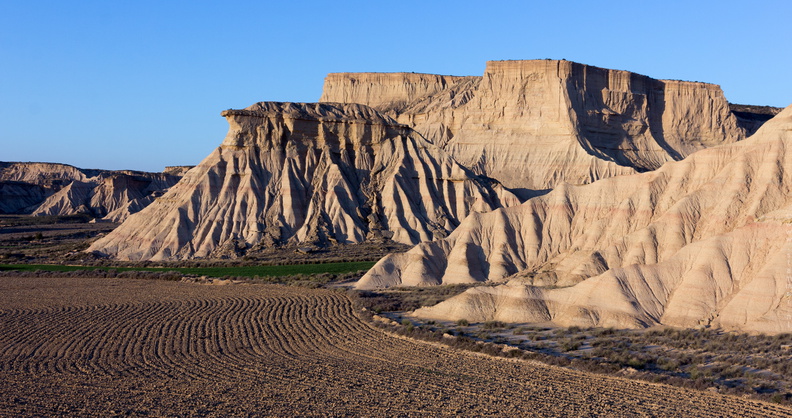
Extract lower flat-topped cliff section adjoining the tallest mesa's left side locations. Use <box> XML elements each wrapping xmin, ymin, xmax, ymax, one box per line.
<box><xmin>319</xmin><ymin>73</ymin><xmax>481</xmax><ymax>112</ymax></box>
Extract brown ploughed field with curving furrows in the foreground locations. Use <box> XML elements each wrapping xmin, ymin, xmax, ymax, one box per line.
<box><xmin>0</xmin><ymin>277</ymin><xmax>792</xmax><ymax>417</ymax></box>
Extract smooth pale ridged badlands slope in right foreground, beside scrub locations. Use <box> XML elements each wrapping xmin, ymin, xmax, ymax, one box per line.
<box><xmin>357</xmin><ymin>106</ymin><xmax>792</xmax><ymax>332</ymax></box>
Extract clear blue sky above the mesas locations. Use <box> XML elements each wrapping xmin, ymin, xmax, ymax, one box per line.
<box><xmin>0</xmin><ymin>0</ymin><xmax>792</xmax><ymax>171</ymax></box>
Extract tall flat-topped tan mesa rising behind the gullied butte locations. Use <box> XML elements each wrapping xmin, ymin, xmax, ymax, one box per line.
<box><xmin>321</xmin><ymin>60</ymin><xmax>746</xmax><ymax>196</ymax></box>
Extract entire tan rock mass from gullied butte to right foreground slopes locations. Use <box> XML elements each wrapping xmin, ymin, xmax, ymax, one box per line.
<box><xmin>82</xmin><ymin>60</ymin><xmax>792</xmax><ymax>332</ymax></box>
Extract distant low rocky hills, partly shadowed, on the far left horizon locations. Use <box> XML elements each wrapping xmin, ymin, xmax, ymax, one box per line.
<box><xmin>0</xmin><ymin>163</ymin><xmax>181</xmax><ymax>222</ymax></box>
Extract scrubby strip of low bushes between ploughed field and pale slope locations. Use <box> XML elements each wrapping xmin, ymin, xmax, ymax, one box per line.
<box><xmin>370</xmin><ymin>321</ymin><xmax>792</xmax><ymax>404</ymax></box>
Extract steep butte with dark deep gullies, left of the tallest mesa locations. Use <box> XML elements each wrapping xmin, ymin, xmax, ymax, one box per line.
<box><xmin>89</xmin><ymin>102</ymin><xmax>519</xmax><ymax>260</ymax></box>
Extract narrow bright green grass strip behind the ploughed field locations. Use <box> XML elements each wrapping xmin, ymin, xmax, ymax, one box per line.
<box><xmin>0</xmin><ymin>261</ymin><xmax>375</xmax><ymax>277</ymax></box>
